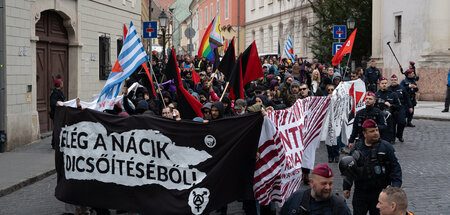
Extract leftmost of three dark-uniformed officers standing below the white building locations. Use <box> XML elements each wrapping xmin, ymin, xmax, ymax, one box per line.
<box><xmin>375</xmin><ymin>77</ymin><xmax>400</xmax><ymax>144</ymax></box>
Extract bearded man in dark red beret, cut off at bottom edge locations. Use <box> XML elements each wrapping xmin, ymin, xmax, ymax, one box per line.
<box><xmin>280</xmin><ymin>163</ymin><xmax>351</xmax><ymax>215</ymax></box>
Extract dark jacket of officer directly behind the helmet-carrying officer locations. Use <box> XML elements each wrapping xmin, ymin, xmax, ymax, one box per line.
<box><xmin>348</xmin><ymin>106</ymin><xmax>386</xmax><ymax>143</ymax></box>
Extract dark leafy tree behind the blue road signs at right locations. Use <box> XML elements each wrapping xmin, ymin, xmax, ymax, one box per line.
<box><xmin>308</xmin><ymin>0</ymin><xmax>372</xmax><ymax>65</ymax></box>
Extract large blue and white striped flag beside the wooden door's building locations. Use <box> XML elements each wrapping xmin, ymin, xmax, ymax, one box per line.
<box><xmin>97</xmin><ymin>22</ymin><xmax>148</xmax><ymax>111</ymax></box>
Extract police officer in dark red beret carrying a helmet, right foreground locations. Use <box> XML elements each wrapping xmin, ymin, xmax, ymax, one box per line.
<box><xmin>340</xmin><ymin>119</ymin><xmax>402</xmax><ymax>215</ymax></box>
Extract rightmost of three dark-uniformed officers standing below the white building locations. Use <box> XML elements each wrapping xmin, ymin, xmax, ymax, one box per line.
<box><xmin>400</xmin><ymin>69</ymin><xmax>419</xmax><ymax>127</ymax></box>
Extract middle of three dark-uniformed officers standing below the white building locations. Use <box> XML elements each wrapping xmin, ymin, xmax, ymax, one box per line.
<box><xmin>388</xmin><ymin>74</ymin><xmax>412</xmax><ymax>143</ymax></box>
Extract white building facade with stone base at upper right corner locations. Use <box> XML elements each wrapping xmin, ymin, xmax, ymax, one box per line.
<box><xmin>372</xmin><ymin>0</ymin><xmax>450</xmax><ymax>101</ymax></box>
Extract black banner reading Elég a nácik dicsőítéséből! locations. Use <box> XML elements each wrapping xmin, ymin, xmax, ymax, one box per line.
<box><xmin>53</xmin><ymin>107</ymin><xmax>263</xmax><ymax>215</ymax></box>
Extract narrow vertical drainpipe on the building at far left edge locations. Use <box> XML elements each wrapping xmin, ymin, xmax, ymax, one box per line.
<box><xmin>0</xmin><ymin>0</ymin><xmax>6</xmax><ymax>152</ymax></box>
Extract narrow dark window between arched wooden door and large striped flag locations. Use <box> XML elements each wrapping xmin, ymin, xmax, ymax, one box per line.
<box><xmin>98</xmin><ymin>35</ymin><xmax>111</xmax><ymax>80</ymax></box>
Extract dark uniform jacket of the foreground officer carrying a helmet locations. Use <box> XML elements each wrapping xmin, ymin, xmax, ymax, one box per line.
<box><xmin>343</xmin><ymin>139</ymin><xmax>402</xmax><ymax>192</ymax></box>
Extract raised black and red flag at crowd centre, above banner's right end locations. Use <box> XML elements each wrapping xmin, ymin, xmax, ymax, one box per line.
<box><xmin>229</xmin><ymin>41</ymin><xmax>264</xmax><ymax>99</ymax></box>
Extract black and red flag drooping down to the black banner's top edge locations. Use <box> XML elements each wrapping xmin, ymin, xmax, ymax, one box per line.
<box><xmin>166</xmin><ymin>47</ymin><xmax>203</xmax><ymax>119</ymax></box>
